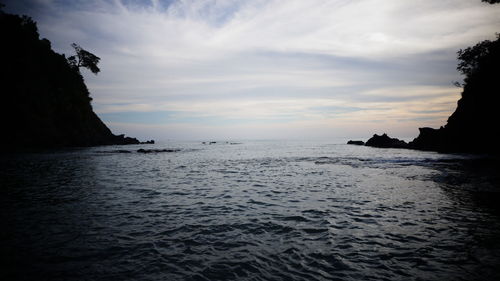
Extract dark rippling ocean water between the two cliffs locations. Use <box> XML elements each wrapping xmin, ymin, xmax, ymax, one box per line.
<box><xmin>0</xmin><ymin>141</ymin><xmax>500</xmax><ymax>280</ymax></box>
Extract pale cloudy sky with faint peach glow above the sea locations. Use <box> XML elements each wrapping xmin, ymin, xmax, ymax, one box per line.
<box><xmin>2</xmin><ymin>0</ymin><xmax>500</xmax><ymax>140</ymax></box>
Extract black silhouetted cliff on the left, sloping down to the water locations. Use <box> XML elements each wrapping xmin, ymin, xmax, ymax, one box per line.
<box><xmin>0</xmin><ymin>11</ymin><xmax>138</xmax><ymax>148</ymax></box>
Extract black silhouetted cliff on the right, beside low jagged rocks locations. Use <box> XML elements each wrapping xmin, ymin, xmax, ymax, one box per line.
<box><xmin>409</xmin><ymin>36</ymin><xmax>500</xmax><ymax>154</ymax></box>
